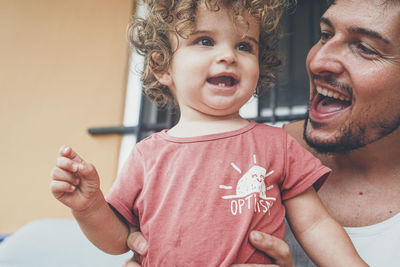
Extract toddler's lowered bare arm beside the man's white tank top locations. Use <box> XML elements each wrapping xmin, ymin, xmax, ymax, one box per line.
<box><xmin>284</xmin><ymin>188</ymin><xmax>367</xmax><ymax>266</ymax></box>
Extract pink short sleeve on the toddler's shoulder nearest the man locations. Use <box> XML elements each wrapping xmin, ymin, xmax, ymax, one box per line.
<box><xmin>281</xmin><ymin>133</ymin><xmax>331</xmax><ymax>200</ymax></box>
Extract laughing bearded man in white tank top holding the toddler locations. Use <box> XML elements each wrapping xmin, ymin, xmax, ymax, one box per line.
<box><xmin>123</xmin><ymin>0</ymin><xmax>400</xmax><ymax>266</ymax></box>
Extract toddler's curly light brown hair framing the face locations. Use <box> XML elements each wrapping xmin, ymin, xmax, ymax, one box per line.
<box><xmin>128</xmin><ymin>0</ymin><xmax>289</xmax><ymax>106</ymax></box>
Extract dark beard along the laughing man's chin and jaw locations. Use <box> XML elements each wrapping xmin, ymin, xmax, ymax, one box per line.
<box><xmin>303</xmin><ymin>111</ymin><xmax>400</xmax><ymax>154</ymax></box>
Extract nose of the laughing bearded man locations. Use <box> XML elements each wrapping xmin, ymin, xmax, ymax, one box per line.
<box><xmin>309</xmin><ymin>39</ymin><xmax>344</xmax><ymax>75</ymax></box>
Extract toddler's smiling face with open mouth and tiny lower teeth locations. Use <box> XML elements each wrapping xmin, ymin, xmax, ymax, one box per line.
<box><xmin>160</xmin><ymin>2</ymin><xmax>260</xmax><ymax>117</ymax></box>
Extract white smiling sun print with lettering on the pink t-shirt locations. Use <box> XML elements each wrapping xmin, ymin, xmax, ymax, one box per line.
<box><xmin>219</xmin><ymin>155</ymin><xmax>276</xmax><ymax>215</ymax></box>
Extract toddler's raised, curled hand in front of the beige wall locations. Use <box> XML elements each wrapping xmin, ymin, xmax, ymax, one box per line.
<box><xmin>50</xmin><ymin>146</ymin><xmax>102</xmax><ymax>211</ymax></box>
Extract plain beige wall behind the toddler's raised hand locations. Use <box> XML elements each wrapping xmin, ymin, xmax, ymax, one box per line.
<box><xmin>0</xmin><ymin>0</ymin><xmax>133</xmax><ymax>233</ymax></box>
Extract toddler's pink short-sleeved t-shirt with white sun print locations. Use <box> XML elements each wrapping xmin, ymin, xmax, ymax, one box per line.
<box><xmin>107</xmin><ymin>121</ymin><xmax>330</xmax><ymax>266</ymax></box>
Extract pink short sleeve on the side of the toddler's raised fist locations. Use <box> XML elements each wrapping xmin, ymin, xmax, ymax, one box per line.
<box><xmin>106</xmin><ymin>147</ymin><xmax>144</xmax><ymax>226</ymax></box>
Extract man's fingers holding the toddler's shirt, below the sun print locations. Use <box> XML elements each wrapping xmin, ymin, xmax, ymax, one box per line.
<box><xmin>232</xmin><ymin>231</ymin><xmax>294</xmax><ymax>267</ymax></box>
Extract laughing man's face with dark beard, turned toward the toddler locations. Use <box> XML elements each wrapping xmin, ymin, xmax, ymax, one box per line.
<box><xmin>304</xmin><ymin>0</ymin><xmax>400</xmax><ymax>152</ymax></box>
